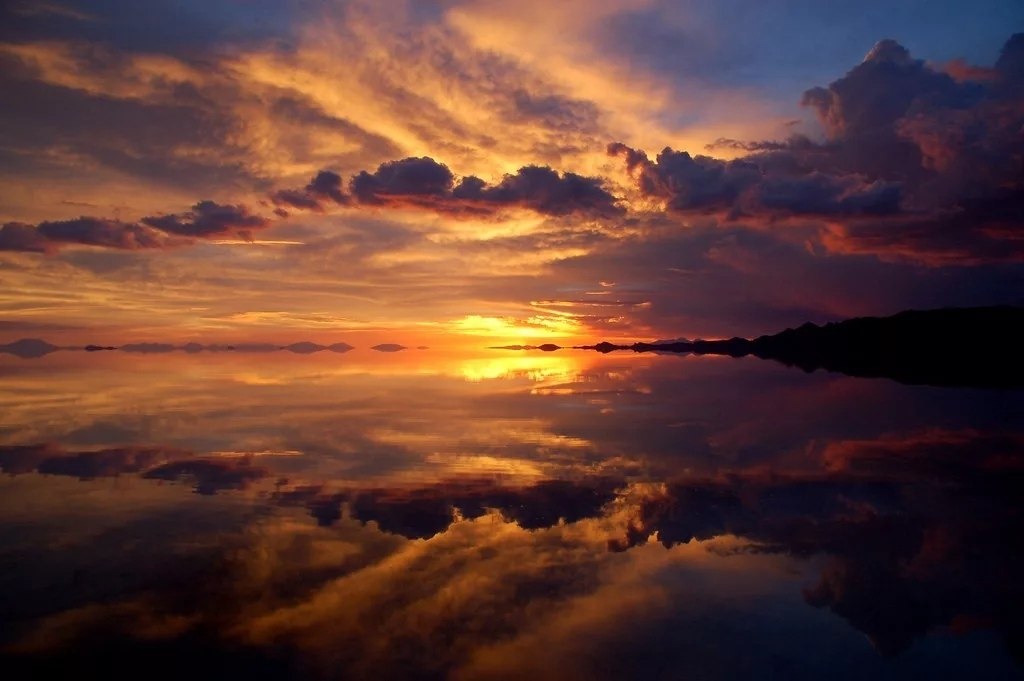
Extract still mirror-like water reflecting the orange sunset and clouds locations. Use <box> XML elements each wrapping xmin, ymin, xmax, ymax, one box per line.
<box><xmin>0</xmin><ymin>350</ymin><xmax>1024</xmax><ymax>679</ymax></box>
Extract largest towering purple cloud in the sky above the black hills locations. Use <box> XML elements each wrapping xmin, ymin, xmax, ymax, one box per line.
<box><xmin>608</xmin><ymin>34</ymin><xmax>1024</xmax><ymax>266</ymax></box>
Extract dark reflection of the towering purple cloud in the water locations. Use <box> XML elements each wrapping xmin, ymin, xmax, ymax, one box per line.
<box><xmin>611</xmin><ymin>431</ymin><xmax>1024</xmax><ymax>654</ymax></box>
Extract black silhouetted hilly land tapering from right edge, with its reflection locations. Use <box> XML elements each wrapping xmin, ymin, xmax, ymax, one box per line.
<box><xmin>520</xmin><ymin>305</ymin><xmax>1024</xmax><ymax>388</ymax></box>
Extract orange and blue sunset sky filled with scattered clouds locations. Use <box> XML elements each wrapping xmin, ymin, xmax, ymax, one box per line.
<box><xmin>0</xmin><ymin>0</ymin><xmax>1024</xmax><ymax>345</ymax></box>
